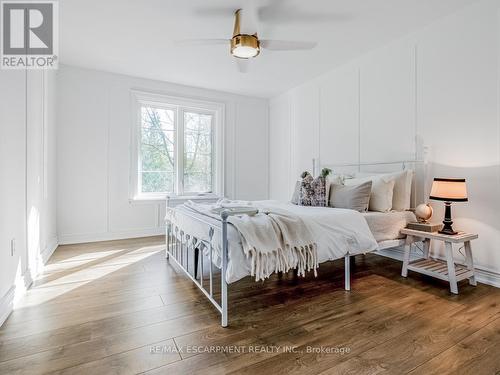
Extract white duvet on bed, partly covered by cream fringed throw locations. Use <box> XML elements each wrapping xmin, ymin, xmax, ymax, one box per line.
<box><xmin>169</xmin><ymin>201</ymin><xmax>377</xmax><ymax>283</ymax></box>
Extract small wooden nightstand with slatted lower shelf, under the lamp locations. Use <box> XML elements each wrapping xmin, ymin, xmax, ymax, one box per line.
<box><xmin>401</xmin><ymin>228</ymin><xmax>478</xmax><ymax>294</ymax></box>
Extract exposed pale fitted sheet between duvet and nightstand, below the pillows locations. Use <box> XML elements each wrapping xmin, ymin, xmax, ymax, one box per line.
<box><xmin>362</xmin><ymin>211</ymin><xmax>417</xmax><ymax>242</ymax></box>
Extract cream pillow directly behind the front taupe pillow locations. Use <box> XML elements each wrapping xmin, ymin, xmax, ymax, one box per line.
<box><xmin>344</xmin><ymin>175</ymin><xmax>395</xmax><ymax>212</ymax></box>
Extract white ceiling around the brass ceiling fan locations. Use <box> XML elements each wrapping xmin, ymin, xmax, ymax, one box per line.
<box><xmin>59</xmin><ymin>0</ymin><xmax>474</xmax><ymax>97</ymax></box>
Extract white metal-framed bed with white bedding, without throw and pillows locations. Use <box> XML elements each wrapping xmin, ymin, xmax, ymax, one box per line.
<box><xmin>166</xmin><ymin>162</ymin><xmax>424</xmax><ymax>327</ymax></box>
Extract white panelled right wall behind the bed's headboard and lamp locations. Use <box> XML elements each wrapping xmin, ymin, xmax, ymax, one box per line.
<box><xmin>270</xmin><ymin>0</ymin><xmax>500</xmax><ymax>286</ymax></box>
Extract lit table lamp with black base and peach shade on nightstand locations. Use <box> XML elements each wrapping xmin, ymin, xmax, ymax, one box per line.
<box><xmin>429</xmin><ymin>178</ymin><xmax>468</xmax><ymax>235</ymax></box>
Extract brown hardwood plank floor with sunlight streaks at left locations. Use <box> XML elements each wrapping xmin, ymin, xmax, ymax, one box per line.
<box><xmin>0</xmin><ymin>237</ymin><xmax>500</xmax><ymax>375</ymax></box>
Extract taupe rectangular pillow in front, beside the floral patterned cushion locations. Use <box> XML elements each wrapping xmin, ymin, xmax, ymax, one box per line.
<box><xmin>328</xmin><ymin>181</ymin><xmax>372</xmax><ymax>212</ymax></box>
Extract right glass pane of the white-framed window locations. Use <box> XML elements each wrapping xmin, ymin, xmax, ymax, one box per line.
<box><xmin>184</xmin><ymin>112</ymin><xmax>213</xmax><ymax>193</ymax></box>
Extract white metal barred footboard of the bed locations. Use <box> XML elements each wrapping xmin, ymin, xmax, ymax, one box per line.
<box><xmin>165</xmin><ymin>206</ymin><xmax>229</xmax><ymax>327</ymax></box>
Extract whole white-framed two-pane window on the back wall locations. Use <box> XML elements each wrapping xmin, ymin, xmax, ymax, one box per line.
<box><xmin>132</xmin><ymin>92</ymin><xmax>223</xmax><ymax>199</ymax></box>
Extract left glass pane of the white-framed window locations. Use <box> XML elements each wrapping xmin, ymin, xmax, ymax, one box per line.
<box><xmin>139</xmin><ymin>106</ymin><xmax>175</xmax><ymax>193</ymax></box>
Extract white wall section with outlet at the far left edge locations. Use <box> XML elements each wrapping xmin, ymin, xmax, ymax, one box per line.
<box><xmin>0</xmin><ymin>70</ymin><xmax>26</xmax><ymax>324</ymax></box>
